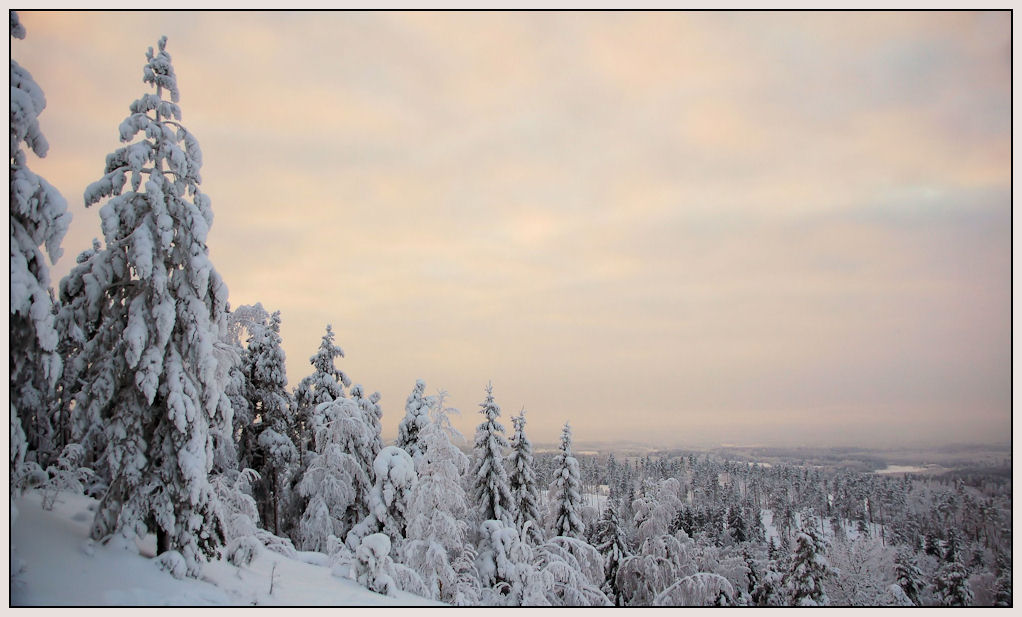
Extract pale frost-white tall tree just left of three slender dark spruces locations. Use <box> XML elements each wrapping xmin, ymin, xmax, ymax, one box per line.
<box><xmin>405</xmin><ymin>391</ymin><xmax>468</xmax><ymax>603</ymax></box>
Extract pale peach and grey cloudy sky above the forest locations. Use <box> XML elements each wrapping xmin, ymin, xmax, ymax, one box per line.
<box><xmin>11</xmin><ymin>12</ymin><xmax>1011</xmax><ymax>445</ymax></box>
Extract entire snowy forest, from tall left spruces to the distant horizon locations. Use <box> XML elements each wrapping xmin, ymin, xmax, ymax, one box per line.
<box><xmin>10</xmin><ymin>12</ymin><xmax>1011</xmax><ymax>606</ymax></box>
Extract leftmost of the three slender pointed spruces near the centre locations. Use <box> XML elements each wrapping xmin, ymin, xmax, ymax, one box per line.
<box><xmin>470</xmin><ymin>384</ymin><xmax>514</xmax><ymax>524</ymax></box>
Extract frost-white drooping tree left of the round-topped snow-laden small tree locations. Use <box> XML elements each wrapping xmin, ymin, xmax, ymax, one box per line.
<box><xmin>298</xmin><ymin>398</ymin><xmax>372</xmax><ymax>552</ymax></box>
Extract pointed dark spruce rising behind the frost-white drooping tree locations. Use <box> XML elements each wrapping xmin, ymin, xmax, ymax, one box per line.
<box><xmin>294</xmin><ymin>324</ymin><xmax>352</xmax><ymax>464</ymax></box>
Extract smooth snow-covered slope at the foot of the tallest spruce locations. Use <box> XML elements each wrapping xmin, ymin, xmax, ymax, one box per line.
<box><xmin>10</xmin><ymin>491</ymin><xmax>442</xmax><ymax>606</ymax></box>
